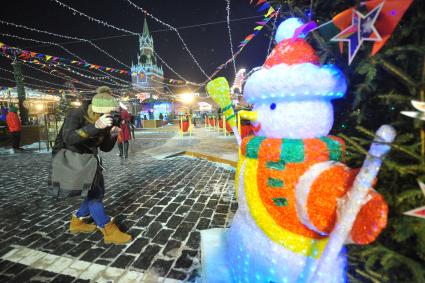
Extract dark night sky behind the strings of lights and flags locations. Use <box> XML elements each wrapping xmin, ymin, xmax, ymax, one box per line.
<box><xmin>0</xmin><ymin>0</ymin><xmax>269</xmax><ymax>91</ymax></box>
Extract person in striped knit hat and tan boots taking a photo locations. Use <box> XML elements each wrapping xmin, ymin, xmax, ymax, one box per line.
<box><xmin>52</xmin><ymin>87</ymin><xmax>131</xmax><ymax>244</ymax></box>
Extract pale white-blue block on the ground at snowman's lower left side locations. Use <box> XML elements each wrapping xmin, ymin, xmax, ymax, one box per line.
<box><xmin>201</xmin><ymin>228</ymin><xmax>233</xmax><ymax>283</ymax></box>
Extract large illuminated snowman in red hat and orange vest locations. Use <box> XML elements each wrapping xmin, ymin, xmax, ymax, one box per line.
<box><xmin>219</xmin><ymin>19</ymin><xmax>388</xmax><ymax>283</ymax></box>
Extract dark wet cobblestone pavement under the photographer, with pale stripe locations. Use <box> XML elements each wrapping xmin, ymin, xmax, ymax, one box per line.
<box><xmin>0</xmin><ymin>133</ymin><xmax>237</xmax><ymax>282</ymax></box>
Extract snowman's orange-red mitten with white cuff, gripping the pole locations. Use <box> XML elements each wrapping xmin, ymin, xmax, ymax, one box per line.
<box><xmin>296</xmin><ymin>162</ymin><xmax>388</xmax><ymax>244</ymax></box>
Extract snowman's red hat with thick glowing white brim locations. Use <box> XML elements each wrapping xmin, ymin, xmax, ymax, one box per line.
<box><xmin>244</xmin><ymin>18</ymin><xmax>347</xmax><ymax>103</ymax></box>
